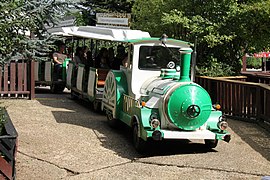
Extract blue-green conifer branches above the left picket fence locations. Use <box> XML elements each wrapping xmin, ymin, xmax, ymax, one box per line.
<box><xmin>0</xmin><ymin>0</ymin><xmax>74</xmax><ymax>63</ymax></box>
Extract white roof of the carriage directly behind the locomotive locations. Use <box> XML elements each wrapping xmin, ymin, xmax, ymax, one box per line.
<box><xmin>68</xmin><ymin>26</ymin><xmax>150</xmax><ymax>41</ymax></box>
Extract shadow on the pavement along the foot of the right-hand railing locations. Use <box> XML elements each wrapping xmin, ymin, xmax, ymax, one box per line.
<box><xmin>228</xmin><ymin>119</ymin><xmax>270</xmax><ymax>161</ymax></box>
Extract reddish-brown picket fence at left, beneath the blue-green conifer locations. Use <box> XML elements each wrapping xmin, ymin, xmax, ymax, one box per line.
<box><xmin>0</xmin><ymin>61</ymin><xmax>35</xmax><ymax>99</ymax></box>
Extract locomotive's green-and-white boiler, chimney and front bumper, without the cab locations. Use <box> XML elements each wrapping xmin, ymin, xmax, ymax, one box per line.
<box><xmin>141</xmin><ymin>49</ymin><xmax>230</xmax><ymax>148</ymax></box>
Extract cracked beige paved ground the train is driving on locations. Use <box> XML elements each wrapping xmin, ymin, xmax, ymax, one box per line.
<box><xmin>1</xmin><ymin>87</ymin><xmax>270</xmax><ymax>180</ymax></box>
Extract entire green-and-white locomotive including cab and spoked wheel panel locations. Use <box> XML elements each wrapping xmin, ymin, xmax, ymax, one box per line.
<box><xmin>103</xmin><ymin>40</ymin><xmax>230</xmax><ymax>151</ymax></box>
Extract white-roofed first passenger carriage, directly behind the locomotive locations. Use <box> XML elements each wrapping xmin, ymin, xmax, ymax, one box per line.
<box><xmin>67</xmin><ymin>26</ymin><xmax>150</xmax><ymax>111</ymax></box>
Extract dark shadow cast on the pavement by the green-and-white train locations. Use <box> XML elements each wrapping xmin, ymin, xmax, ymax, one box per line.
<box><xmin>37</xmin><ymin>88</ymin><xmax>216</xmax><ymax>160</ymax></box>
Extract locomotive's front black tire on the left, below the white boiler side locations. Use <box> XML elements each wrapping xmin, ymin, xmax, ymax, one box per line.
<box><xmin>132</xmin><ymin>124</ymin><xmax>146</xmax><ymax>153</ymax></box>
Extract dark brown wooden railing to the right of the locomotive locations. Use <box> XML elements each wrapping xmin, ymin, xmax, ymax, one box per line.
<box><xmin>196</xmin><ymin>76</ymin><xmax>270</xmax><ymax>126</ymax></box>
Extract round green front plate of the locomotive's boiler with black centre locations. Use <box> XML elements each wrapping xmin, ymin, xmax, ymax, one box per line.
<box><xmin>165</xmin><ymin>84</ymin><xmax>212</xmax><ymax>130</ymax></box>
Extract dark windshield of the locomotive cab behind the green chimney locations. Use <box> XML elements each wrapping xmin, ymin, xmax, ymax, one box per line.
<box><xmin>139</xmin><ymin>46</ymin><xmax>180</xmax><ymax>70</ymax></box>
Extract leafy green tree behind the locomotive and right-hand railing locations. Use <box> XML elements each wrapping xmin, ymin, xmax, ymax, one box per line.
<box><xmin>132</xmin><ymin>0</ymin><xmax>270</xmax><ymax>73</ymax></box>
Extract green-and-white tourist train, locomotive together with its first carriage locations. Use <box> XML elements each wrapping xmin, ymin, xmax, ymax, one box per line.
<box><xmin>35</xmin><ymin>26</ymin><xmax>230</xmax><ymax>151</ymax></box>
